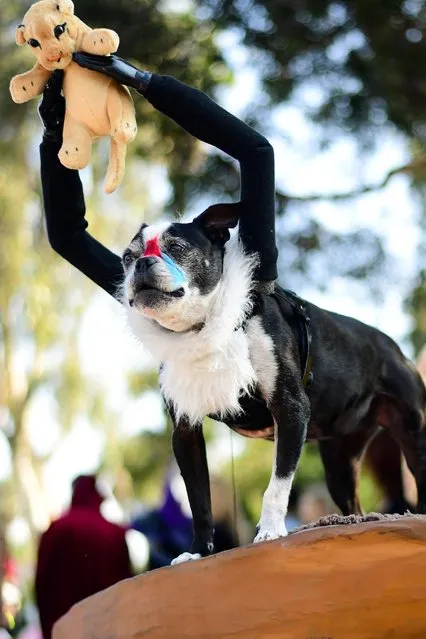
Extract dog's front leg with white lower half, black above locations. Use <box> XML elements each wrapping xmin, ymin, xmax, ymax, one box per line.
<box><xmin>254</xmin><ymin>388</ymin><xmax>310</xmax><ymax>543</ymax></box>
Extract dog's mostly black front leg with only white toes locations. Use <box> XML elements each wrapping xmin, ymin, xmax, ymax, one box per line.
<box><xmin>169</xmin><ymin>411</ymin><xmax>214</xmax><ymax>564</ymax></box>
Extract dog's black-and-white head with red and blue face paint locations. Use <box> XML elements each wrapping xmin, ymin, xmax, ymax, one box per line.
<box><xmin>122</xmin><ymin>204</ymin><xmax>239</xmax><ymax>331</ymax></box>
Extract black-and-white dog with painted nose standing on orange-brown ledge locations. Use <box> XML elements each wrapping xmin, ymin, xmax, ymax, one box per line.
<box><xmin>121</xmin><ymin>204</ymin><xmax>426</xmax><ymax>563</ymax></box>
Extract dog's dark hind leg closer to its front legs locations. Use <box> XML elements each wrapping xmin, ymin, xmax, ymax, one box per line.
<box><xmin>318</xmin><ymin>429</ymin><xmax>372</xmax><ymax>515</ymax></box>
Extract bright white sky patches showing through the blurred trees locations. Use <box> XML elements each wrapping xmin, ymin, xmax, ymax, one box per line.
<box><xmin>0</xmin><ymin>20</ymin><xmax>418</xmax><ymax>540</ymax></box>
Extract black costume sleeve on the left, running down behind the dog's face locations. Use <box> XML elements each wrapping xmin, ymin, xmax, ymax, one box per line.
<box><xmin>40</xmin><ymin>141</ymin><xmax>123</xmax><ymax>296</ymax></box>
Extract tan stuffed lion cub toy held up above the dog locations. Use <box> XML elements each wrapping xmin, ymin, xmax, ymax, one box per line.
<box><xmin>10</xmin><ymin>0</ymin><xmax>136</xmax><ymax>193</ymax></box>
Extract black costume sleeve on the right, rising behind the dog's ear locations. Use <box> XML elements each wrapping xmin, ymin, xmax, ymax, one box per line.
<box><xmin>141</xmin><ymin>73</ymin><xmax>277</xmax><ymax>281</ymax></box>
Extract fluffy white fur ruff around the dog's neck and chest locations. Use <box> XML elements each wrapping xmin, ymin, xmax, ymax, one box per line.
<box><xmin>127</xmin><ymin>235</ymin><xmax>276</xmax><ymax>424</ymax></box>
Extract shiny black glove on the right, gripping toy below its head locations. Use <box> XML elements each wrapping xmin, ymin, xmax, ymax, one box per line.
<box><xmin>73</xmin><ymin>52</ymin><xmax>152</xmax><ymax>95</ymax></box>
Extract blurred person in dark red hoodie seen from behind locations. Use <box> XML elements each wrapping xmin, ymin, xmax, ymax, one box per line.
<box><xmin>35</xmin><ymin>475</ymin><xmax>133</xmax><ymax>639</ymax></box>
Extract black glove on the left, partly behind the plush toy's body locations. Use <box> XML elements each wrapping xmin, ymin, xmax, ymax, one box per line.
<box><xmin>38</xmin><ymin>70</ymin><xmax>65</xmax><ymax>143</ymax></box>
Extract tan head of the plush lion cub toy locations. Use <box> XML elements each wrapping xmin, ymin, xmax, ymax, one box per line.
<box><xmin>16</xmin><ymin>0</ymin><xmax>77</xmax><ymax>71</ymax></box>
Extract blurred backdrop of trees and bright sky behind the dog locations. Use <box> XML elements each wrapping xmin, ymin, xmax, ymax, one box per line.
<box><xmin>0</xmin><ymin>0</ymin><xmax>426</xmax><ymax>636</ymax></box>
